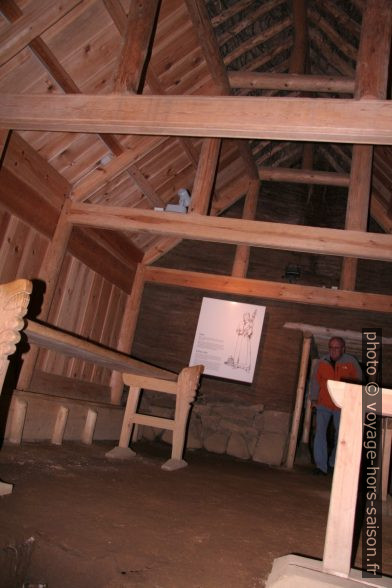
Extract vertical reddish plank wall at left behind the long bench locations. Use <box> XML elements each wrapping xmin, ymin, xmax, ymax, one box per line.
<box><xmin>0</xmin><ymin>207</ymin><xmax>126</xmax><ymax>386</ymax></box>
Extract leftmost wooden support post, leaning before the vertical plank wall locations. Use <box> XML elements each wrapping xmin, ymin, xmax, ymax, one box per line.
<box><xmin>17</xmin><ymin>200</ymin><xmax>72</xmax><ymax>390</ymax></box>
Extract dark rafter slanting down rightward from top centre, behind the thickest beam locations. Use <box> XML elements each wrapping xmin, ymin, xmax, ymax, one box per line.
<box><xmin>185</xmin><ymin>0</ymin><xmax>258</xmax><ymax>179</ymax></box>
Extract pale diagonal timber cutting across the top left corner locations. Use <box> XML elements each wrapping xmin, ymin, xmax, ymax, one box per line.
<box><xmin>0</xmin><ymin>0</ymin><xmax>82</xmax><ymax>65</ymax></box>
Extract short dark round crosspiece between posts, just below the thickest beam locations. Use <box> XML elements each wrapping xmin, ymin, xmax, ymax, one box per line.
<box><xmin>259</xmin><ymin>166</ymin><xmax>350</xmax><ymax>187</ymax></box>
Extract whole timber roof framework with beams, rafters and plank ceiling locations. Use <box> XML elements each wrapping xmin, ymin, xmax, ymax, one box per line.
<box><xmin>0</xmin><ymin>0</ymin><xmax>392</xmax><ymax>400</ymax></box>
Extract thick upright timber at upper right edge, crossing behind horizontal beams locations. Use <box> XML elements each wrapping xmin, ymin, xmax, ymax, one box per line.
<box><xmin>340</xmin><ymin>0</ymin><xmax>392</xmax><ymax>290</ymax></box>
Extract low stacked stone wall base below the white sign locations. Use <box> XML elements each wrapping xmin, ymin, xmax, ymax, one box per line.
<box><xmin>139</xmin><ymin>400</ymin><xmax>290</xmax><ymax>466</ymax></box>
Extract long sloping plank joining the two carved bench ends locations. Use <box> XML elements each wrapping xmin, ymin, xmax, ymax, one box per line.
<box><xmin>25</xmin><ymin>320</ymin><xmax>177</xmax><ymax>380</ymax></box>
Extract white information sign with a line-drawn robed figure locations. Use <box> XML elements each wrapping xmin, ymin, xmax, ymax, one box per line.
<box><xmin>189</xmin><ymin>298</ymin><xmax>265</xmax><ymax>382</ymax></box>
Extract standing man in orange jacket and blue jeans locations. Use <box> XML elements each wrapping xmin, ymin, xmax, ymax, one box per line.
<box><xmin>310</xmin><ymin>337</ymin><xmax>362</xmax><ymax>476</ymax></box>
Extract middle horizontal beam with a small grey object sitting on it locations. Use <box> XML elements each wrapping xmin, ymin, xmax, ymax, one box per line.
<box><xmin>69</xmin><ymin>203</ymin><xmax>392</xmax><ymax>261</ymax></box>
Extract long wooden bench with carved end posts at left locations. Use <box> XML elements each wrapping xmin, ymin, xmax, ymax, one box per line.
<box><xmin>0</xmin><ymin>279</ymin><xmax>203</xmax><ymax>474</ymax></box>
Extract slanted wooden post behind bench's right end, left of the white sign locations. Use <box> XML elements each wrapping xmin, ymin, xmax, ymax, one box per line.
<box><xmin>110</xmin><ymin>263</ymin><xmax>144</xmax><ymax>404</ymax></box>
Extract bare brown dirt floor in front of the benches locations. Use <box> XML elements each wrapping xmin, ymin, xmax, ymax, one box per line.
<box><xmin>0</xmin><ymin>443</ymin><xmax>392</xmax><ymax>588</ymax></box>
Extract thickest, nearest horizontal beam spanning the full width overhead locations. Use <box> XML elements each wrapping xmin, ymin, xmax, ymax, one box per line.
<box><xmin>0</xmin><ymin>94</ymin><xmax>392</xmax><ymax>145</ymax></box>
